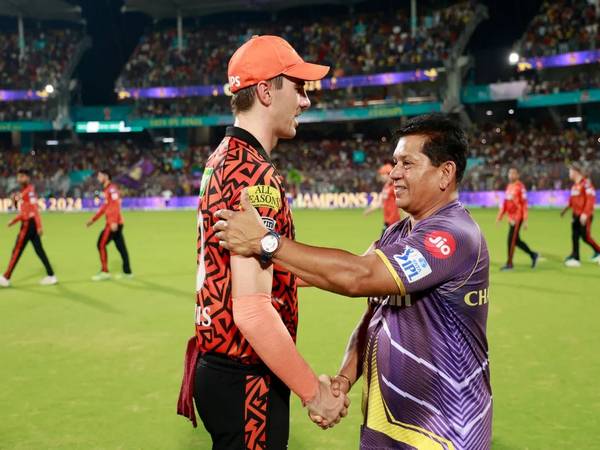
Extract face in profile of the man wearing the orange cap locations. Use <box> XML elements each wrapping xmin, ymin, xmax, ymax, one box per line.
<box><xmin>270</xmin><ymin>77</ymin><xmax>310</xmax><ymax>139</ymax></box>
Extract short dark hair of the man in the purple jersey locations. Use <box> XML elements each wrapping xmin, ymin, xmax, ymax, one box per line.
<box><xmin>396</xmin><ymin>113</ymin><xmax>469</xmax><ymax>184</ymax></box>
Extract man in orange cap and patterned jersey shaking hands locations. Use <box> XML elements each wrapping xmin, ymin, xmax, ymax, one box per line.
<box><xmin>178</xmin><ymin>36</ymin><xmax>348</xmax><ymax>449</ymax></box>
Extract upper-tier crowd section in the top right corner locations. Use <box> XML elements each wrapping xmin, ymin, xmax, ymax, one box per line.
<box><xmin>521</xmin><ymin>0</ymin><xmax>600</xmax><ymax>56</ymax></box>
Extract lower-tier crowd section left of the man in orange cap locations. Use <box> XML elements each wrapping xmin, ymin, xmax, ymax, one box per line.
<box><xmin>0</xmin><ymin>140</ymin><xmax>210</xmax><ymax>197</ymax></box>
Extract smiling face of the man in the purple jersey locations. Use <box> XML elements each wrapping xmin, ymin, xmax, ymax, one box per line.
<box><xmin>390</xmin><ymin>135</ymin><xmax>444</xmax><ymax>217</ymax></box>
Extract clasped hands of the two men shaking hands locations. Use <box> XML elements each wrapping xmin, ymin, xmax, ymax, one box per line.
<box><xmin>306</xmin><ymin>375</ymin><xmax>351</xmax><ymax>430</ymax></box>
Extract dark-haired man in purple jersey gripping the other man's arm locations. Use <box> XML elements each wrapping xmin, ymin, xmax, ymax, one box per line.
<box><xmin>216</xmin><ymin>114</ymin><xmax>492</xmax><ymax>450</ymax></box>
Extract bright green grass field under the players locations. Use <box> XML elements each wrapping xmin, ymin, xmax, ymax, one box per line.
<box><xmin>0</xmin><ymin>210</ymin><xmax>600</xmax><ymax>450</ymax></box>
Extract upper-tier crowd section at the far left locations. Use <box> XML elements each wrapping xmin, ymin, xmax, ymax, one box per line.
<box><xmin>0</xmin><ymin>28</ymin><xmax>82</xmax><ymax>90</ymax></box>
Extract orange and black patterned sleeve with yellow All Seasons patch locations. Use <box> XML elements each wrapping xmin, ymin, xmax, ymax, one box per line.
<box><xmin>228</xmin><ymin>164</ymin><xmax>287</xmax><ymax>234</ymax></box>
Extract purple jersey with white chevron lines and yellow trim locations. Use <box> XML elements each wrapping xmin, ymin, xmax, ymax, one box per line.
<box><xmin>361</xmin><ymin>201</ymin><xmax>492</xmax><ymax>450</ymax></box>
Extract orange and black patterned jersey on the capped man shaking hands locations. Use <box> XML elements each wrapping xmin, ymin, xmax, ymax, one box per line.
<box><xmin>196</xmin><ymin>127</ymin><xmax>298</xmax><ymax>364</ymax></box>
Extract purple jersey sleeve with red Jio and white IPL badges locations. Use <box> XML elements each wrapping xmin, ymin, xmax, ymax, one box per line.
<box><xmin>375</xmin><ymin>224</ymin><xmax>480</xmax><ymax>295</ymax></box>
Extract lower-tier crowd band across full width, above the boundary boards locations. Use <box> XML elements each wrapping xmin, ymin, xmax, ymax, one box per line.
<box><xmin>0</xmin><ymin>121</ymin><xmax>600</xmax><ymax>197</ymax></box>
